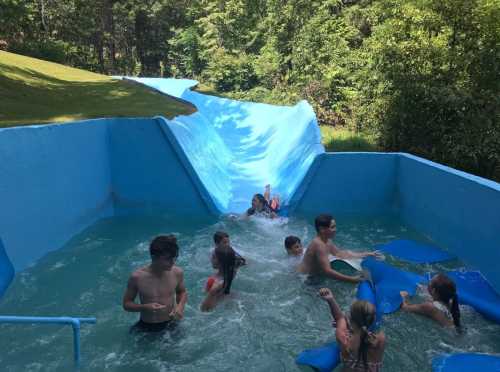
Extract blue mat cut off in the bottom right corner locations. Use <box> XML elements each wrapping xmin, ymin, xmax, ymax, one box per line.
<box><xmin>432</xmin><ymin>353</ymin><xmax>500</xmax><ymax>372</ymax></box>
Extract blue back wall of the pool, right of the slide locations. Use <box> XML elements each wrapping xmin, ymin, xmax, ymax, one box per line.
<box><xmin>292</xmin><ymin>153</ymin><xmax>398</xmax><ymax>216</ymax></box>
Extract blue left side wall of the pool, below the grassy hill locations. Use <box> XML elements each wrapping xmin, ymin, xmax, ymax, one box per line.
<box><xmin>0</xmin><ymin>120</ymin><xmax>113</xmax><ymax>270</ymax></box>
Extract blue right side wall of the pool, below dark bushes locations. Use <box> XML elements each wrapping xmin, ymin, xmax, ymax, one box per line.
<box><xmin>397</xmin><ymin>154</ymin><xmax>500</xmax><ymax>291</ymax></box>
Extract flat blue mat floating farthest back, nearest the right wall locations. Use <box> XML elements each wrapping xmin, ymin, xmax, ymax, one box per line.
<box><xmin>376</xmin><ymin>239</ymin><xmax>454</xmax><ymax>263</ymax></box>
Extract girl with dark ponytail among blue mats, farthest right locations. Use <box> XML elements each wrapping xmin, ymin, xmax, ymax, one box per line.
<box><xmin>400</xmin><ymin>274</ymin><xmax>461</xmax><ymax>331</ymax></box>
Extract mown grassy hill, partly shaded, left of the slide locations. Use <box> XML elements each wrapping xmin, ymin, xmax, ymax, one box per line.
<box><xmin>0</xmin><ymin>51</ymin><xmax>194</xmax><ymax>127</ymax></box>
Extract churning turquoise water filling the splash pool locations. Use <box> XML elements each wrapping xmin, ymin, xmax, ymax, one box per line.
<box><xmin>0</xmin><ymin>217</ymin><xmax>500</xmax><ymax>371</ymax></box>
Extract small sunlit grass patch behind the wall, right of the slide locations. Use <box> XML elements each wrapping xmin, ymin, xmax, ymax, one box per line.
<box><xmin>320</xmin><ymin>126</ymin><xmax>380</xmax><ymax>152</ymax></box>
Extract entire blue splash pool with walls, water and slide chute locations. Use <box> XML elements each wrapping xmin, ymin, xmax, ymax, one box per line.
<box><xmin>0</xmin><ymin>79</ymin><xmax>500</xmax><ymax>371</ymax></box>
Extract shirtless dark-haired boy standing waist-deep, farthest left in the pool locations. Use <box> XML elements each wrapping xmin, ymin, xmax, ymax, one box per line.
<box><xmin>123</xmin><ymin>235</ymin><xmax>187</xmax><ymax>332</ymax></box>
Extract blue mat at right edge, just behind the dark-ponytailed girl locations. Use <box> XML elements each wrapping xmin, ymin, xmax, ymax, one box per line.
<box><xmin>446</xmin><ymin>271</ymin><xmax>500</xmax><ymax>323</ymax></box>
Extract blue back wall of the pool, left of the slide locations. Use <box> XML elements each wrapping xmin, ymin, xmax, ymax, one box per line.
<box><xmin>110</xmin><ymin>118</ymin><xmax>216</xmax><ymax>216</ymax></box>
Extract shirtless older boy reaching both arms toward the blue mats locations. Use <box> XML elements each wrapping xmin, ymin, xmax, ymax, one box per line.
<box><xmin>298</xmin><ymin>214</ymin><xmax>379</xmax><ymax>283</ymax></box>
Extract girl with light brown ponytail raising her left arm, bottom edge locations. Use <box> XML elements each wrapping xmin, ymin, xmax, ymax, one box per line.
<box><xmin>319</xmin><ymin>288</ymin><xmax>385</xmax><ymax>372</ymax></box>
